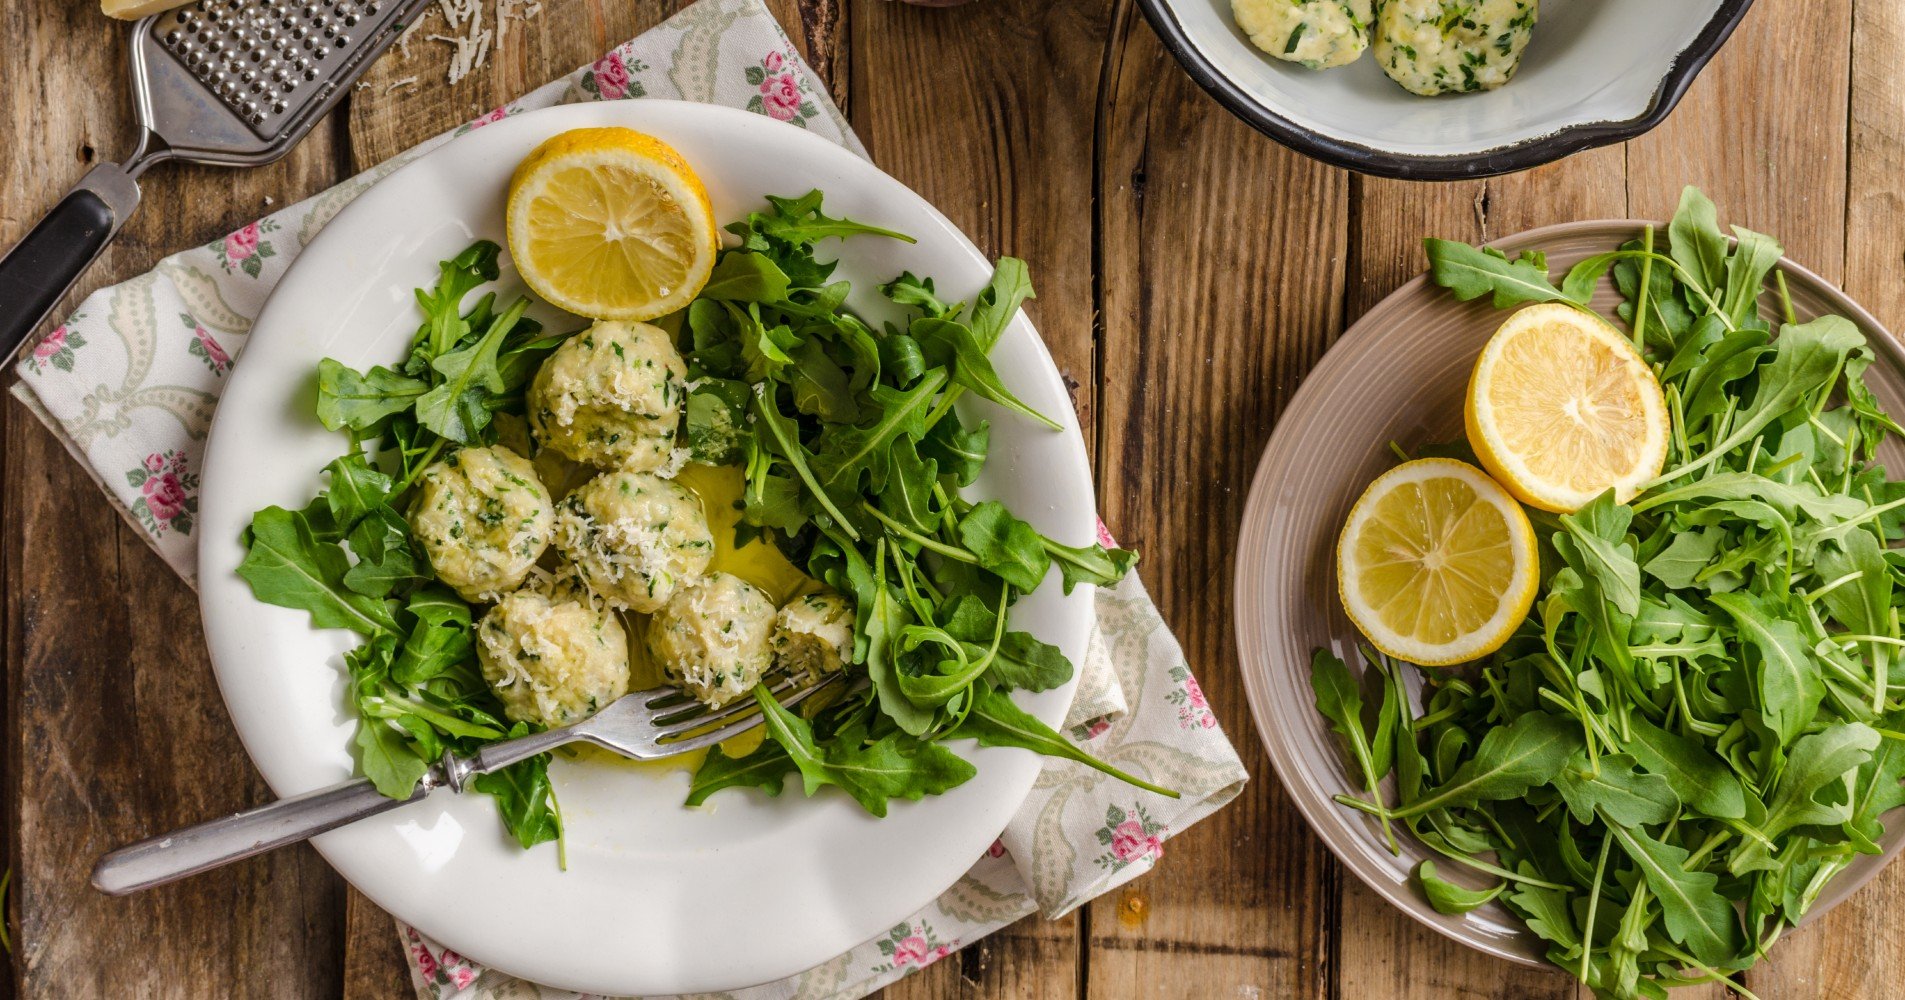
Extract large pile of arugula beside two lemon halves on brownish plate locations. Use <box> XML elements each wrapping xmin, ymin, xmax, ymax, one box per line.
<box><xmin>1311</xmin><ymin>189</ymin><xmax>1905</xmax><ymax>998</ymax></box>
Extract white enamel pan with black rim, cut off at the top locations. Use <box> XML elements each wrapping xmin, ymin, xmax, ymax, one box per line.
<box><xmin>1139</xmin><ymin>0</ymin><xmax>1753</xmax><ymax>179</ymax></box>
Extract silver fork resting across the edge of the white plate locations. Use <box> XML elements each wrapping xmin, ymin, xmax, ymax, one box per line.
<box><xmin>93</xmin><ymin>674</ymin><xmax>840</xmax><ymax>895</ymax></box>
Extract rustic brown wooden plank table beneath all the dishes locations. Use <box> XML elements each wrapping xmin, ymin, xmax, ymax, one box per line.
<box><xmin>0</xmin><ymin>0</ymin><xmax>1905</xmax><ymax>1000</ymax></box>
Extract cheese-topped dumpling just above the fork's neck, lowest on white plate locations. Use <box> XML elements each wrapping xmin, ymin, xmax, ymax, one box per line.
<box><xmin>476</xmin><ymin>590</ymin><xmax>629</xmax><ymax>726</ymax></box>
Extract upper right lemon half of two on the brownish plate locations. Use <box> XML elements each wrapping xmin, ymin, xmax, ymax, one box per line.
<box><xmin>1465</xmin><ymin>303</ymin><xmax>1667</xmax><ymax>512</ymax></box>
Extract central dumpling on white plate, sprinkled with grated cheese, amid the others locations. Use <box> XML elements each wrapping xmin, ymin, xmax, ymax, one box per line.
<box><xmin>554</xmin><ymin>472</ymin><xmax>714</xmax><ymax>613</ymax></box>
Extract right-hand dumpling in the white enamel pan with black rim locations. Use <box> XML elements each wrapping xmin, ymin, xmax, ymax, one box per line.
<box><xmin>1375</xmin><ymin>0</ymin><xmax>1537</xmax><ymax>97</ymax></box>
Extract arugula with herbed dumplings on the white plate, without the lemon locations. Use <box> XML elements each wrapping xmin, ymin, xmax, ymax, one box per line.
<box><xmin>238</xmin><ymin>182</ymin><xmax>1173</xmax><ymax>848</ymax></box>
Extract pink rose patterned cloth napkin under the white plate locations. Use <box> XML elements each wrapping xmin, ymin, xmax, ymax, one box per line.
<box><xmin>13</xmin><ymin>0</ymin><xmax>1248</xmax><ymax>1000</ymax></box>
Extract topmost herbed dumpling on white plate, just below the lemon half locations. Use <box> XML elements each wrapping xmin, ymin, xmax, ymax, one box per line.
<box><xmin>528</xmin><ymin>322</ymin><xmax>688</xmax><ymax>470</ymax></box>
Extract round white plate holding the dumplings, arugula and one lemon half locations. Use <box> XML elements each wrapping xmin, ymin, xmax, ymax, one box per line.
<box><xmin>198</xmin><ymin>101</ymin><xmax>1095</xmax><ymax>994</ymax></box>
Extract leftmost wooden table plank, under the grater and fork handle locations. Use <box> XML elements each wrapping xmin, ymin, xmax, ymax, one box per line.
<box><xmin>0</xmin><ymin>0</ymin><xmax>343</xmax><ymax>996</ymax></box>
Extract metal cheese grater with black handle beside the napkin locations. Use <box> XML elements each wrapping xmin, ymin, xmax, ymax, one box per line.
<box><xmin>0</xmin><ymin>0</ymin><xmax>429</xmax><ymax>366</ymax></box>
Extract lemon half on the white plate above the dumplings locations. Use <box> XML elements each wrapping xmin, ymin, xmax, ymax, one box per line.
<box><xmin>507</xmin><ymin>128</ymin><xmax>720</xmax><ymax>320</ymax></box>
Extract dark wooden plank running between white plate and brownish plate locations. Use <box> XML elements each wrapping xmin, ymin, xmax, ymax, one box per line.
<box><xmin>1086</xmin><ymin>4</ymin><xmax>1351</xmax><ymax>996</ymax></box>
